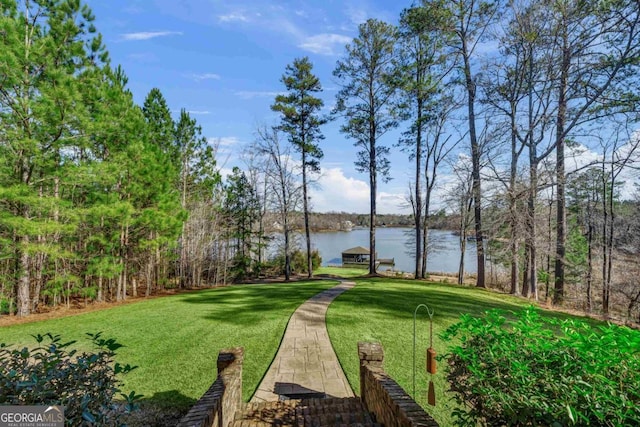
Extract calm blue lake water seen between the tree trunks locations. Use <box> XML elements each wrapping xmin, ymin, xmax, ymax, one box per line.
<box><xmin>311</xmin><ymin>227</ymin><xmax>477</xmax><ymax>273</ymax></box>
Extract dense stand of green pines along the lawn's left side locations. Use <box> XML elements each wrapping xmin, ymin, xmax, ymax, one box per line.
<box><xmin>0</xmin><ymin>0</ymin><xmax>257</xmax><ymax>316</ymax></box>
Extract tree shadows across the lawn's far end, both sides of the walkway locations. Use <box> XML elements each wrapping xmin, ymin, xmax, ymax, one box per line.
<box><xmin>175</xmin><ymin>276</ymin><xmax>596</xmax><ymax>332</ymax></box>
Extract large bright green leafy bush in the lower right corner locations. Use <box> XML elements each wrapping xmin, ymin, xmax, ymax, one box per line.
<box><xmin>442</xmin><ymin>307</ymin><xmax>640</xmax><ymax>426</ymax></box>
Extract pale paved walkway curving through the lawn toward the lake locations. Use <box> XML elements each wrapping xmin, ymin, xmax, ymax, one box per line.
<box><xmin>251</xmin><ymin>281</ymin><xmax>355</xmax><ymax>403</ymax></box>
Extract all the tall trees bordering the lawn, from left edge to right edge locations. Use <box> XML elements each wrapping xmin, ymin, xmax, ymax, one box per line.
<box><xmin>5</xmin><ymin>0</ymin><xmax>640</xmax><ymax>319</ymax></box>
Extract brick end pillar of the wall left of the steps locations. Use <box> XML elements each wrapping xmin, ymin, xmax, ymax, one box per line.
<box><xmin>217</xmin><ymin>347</ymin><xmax>244</xmax><ymax>427</ymax></box>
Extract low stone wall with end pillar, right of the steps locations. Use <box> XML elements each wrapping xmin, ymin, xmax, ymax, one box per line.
<box><xmin>358</xmin><ymin>342</ymin><xmax>438</xmax><ymax>427</ymax></box>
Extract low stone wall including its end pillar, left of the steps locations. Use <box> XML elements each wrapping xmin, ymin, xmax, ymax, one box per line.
<box><xmin>178</xmin><ymin>347</ymin><xmax>244</xmax><ymax>427</ymax></box>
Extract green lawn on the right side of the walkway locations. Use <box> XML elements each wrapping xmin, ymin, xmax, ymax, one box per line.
<box><xmin>327</xmin><ymin>278</ymin><xmax>596</xmax><ymax>426</ymax></box>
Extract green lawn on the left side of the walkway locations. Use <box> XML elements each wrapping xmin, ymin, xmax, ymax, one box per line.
<box><xmin>0</xmin><ymin>281</ymin><xmax>335</xmax><ymax>409</ymax></box>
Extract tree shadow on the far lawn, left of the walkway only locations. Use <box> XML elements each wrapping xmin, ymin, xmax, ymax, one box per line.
<box><xmin>175</xmin><ymin>281</ymin><xmax>337</xmax><ymax>325</ymax></box>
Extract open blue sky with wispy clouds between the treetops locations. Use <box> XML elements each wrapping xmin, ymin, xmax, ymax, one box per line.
<box><xmin>87</xmin><ymin>0</ymin><xmax>424</xmax><ymax>213</ymax></box>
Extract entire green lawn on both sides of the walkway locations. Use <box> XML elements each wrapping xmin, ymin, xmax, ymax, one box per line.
<box><xmin>0</xmin><ymin>268</ymin><xmax>600</xmax><ymax>425</ymax></box>
